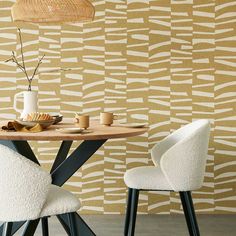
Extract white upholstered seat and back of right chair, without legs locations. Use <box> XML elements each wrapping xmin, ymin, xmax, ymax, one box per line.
<box><xmin>124</xmin><ymin>120</ymin><xmax>210</xmax><ymax>191</ymax></box>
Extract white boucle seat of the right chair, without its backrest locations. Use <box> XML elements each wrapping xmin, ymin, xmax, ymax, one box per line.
<box><xmin>124</xmin><ymin>166</ymin><xmax>173</xmax><ymax>190</ymax></box>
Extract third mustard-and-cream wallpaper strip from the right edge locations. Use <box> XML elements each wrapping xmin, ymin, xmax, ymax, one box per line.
<box><xmin>170</xmin><ymin>0</ymin><xmax>193</xmax><ymax>213</ymax></box>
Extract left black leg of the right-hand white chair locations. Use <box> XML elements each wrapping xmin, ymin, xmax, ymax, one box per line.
<box><xmin>128</xmin><ymin>189</ymin><xmax>139</xmax><ymax>236</ymax></box>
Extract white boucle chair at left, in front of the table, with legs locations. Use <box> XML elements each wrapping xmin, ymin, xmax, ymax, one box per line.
<box><xmin>0</xmin><ymin>145</ymin><xmax>80</xmax><ymax>236</ymax></box>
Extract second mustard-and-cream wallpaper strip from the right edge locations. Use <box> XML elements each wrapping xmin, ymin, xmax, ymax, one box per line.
<box><xmin>192</xmin><ymin>0</ymin><xmax>215</xmax><ymax>213</ymax></box>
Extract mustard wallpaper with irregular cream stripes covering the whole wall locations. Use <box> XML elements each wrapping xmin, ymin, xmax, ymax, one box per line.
<box><xmin>0</xmin><ymin>0</ymin><xmax>236</xmax><ymax>214</ymax></box>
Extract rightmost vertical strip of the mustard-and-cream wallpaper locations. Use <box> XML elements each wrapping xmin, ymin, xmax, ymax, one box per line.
<box><xmin>214</xmin><ymin>0</ymin><xmax>236</xmax><ymax>213</ymax></box>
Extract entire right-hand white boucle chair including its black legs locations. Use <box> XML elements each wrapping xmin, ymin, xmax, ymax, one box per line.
<box><xmin>124</xmin><ymin>120</ymin><xmax>210</xmax><ymax>236</ymax></box>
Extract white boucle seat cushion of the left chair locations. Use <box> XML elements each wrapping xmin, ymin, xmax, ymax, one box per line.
<box><xmin>40</xmin><ymin>185</ymin><xmax>81</xmax><ymax>217</ymax></box>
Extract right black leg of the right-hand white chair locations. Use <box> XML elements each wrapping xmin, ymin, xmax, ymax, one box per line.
<box><xmin>180</xmin><ymin>191</ymin><xmax>200</xmax><ymax>236</ymax></box>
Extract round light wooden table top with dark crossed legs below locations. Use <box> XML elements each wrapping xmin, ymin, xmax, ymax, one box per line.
<box><xmin>0</xmin><ymin>119</ymin><xmax>148</xmax><ymax>141</ymax></box>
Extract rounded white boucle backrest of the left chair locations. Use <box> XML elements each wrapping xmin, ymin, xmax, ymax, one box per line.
<box><xmin>0</xmin><ymin>145</ymin><xmax>51</xmax><ymax>222</ymax></box>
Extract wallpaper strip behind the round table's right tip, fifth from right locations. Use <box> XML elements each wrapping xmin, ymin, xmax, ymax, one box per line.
<box><xmin>126</xmin><ymin>1</ymin><xmax>149</xmax><ymax>213</ymax></box>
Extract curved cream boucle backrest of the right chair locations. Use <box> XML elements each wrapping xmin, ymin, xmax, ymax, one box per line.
<box><xmin>153</xmin><ymin>120</ymin><xmax>210</xmax><ymax>191</ymax></box>
